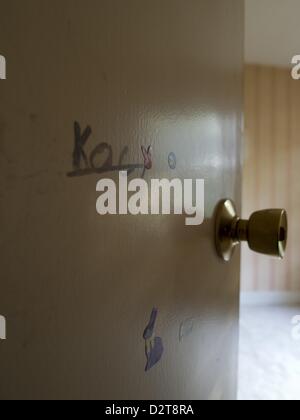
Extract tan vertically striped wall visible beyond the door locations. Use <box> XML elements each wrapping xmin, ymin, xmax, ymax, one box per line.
<box><xmin>242</xmin><ymin>65</ymin><xmax>300</xmax><ymax>291</ymax></box>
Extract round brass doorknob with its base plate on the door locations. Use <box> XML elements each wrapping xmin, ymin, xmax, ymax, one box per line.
<box><xmin>215</xmin><ymin>200</ymin><xmax>288</xmax><ymax>261</ymax></box>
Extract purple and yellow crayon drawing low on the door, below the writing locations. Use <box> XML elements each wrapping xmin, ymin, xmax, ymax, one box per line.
<box><xmin>143</xmin><ymin>308</ymin><xmax>164</xmax><ymax>372</ymax></box>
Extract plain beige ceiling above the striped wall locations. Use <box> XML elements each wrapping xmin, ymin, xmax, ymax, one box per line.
<box><xmin>245</xmin><ymin>0</ymin><xmax>300</xmax><ymax>67</ymax></box>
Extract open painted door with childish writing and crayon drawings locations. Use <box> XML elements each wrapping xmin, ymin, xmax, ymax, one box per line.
<box><xmin>0</xmin><ymin>0</ymin><xmax>243</xmax><ymax>399</ymax></box>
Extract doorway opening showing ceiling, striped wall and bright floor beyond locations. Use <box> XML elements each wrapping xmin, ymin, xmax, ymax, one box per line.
<box><xmin>239</xmin><ymin>0</ymin><xmax>300</xmax><ymax>400</ymax></box>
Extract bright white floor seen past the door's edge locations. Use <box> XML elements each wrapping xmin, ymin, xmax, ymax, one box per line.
<box><xmin>238</xmin><ymin>306</ymin><xmax>300</xmax><ymax>401</ymax></box>
